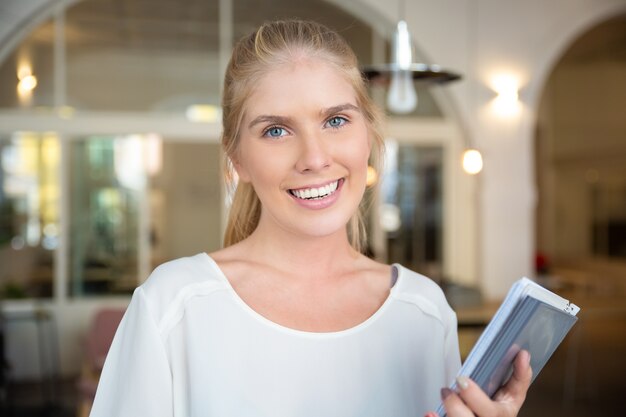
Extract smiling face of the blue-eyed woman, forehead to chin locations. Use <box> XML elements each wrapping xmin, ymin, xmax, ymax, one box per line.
<box><xmin>234</xmin><ymin>60</ymin><xmax>370</xmax><ymax>237</ymax></box>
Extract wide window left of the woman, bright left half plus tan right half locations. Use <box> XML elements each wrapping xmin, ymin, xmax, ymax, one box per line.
<box><xmin>69</xmin><ymin>135</ymin><xmax>221</xmax><ymax>297</ymax></box>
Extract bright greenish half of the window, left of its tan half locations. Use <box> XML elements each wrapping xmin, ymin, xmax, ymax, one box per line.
<box><xmin>69</xmin><ymin>136</ymin><xmax>146</xmax><ymax>296</ymax></box>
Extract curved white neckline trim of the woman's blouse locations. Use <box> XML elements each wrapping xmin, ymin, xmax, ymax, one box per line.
<box><xmin>202</xmin><ymin>252</ymin><xmax>402</xmax><ymax>338</ymax></box>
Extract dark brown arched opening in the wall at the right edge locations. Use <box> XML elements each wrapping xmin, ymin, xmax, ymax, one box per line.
<box><xmin>535</xmin><ymin>14</ymin><xmax>626</xmax><ymax>287</ymax></box>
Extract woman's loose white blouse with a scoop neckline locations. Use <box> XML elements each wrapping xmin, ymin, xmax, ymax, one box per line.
<box><xmin>91</xmin><ymin>253</ymin><xmax>461</xmax><ymax>417</ymax></box>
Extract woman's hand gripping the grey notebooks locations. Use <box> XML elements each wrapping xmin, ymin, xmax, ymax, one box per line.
<box><xmin>425</xmin><ymin>350</ymin><xmax>533</xmax><ymax>417</ymax></box>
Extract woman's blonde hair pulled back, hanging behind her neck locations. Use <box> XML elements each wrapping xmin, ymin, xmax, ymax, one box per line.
<box><xmin>222</xmin><ymin>20</ymin><xmax>383</xmax><ymax>251</ymax></box>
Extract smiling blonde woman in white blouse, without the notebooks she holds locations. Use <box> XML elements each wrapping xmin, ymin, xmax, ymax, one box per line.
<box><xmin>92</xmin><ymin>21</ymin><xmax>531</xmax><ymax>417</ymax></box>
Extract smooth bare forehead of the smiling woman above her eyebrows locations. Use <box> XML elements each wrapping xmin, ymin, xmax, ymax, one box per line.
<box><xmin>245</xmin><ymin>59</ymin><xmax>358</xmax><ymax>118</ymax></box>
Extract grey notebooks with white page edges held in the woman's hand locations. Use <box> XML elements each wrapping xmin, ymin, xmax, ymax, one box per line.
<box><xmin>437</xmin><ymin>278</ymin><xmax>580</xmax><ymax>417</ymax></box>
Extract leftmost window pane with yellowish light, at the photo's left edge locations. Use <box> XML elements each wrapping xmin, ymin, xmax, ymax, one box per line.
<box><xmin>0</xmin><ymin>132</ymin><xmax>60</xmax><ymax>298</ymax></box>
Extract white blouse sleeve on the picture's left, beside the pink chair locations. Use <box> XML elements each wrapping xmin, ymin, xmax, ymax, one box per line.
<box><xmin>90</xmin><ymin>287</ymin><xmax>173</xmax><ymax>417</ymax></box>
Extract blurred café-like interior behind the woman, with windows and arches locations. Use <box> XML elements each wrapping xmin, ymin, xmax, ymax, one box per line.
<box><xmin>0</xmin><ymin>0</ymin><xmax>626</xmax><ymax>416</ymax></box>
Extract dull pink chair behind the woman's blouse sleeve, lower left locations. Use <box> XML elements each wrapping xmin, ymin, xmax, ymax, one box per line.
<box><xmin>78</xmin><ymin>308</ymin><xmax>125</xmax><ymax>417</ymax></box>
